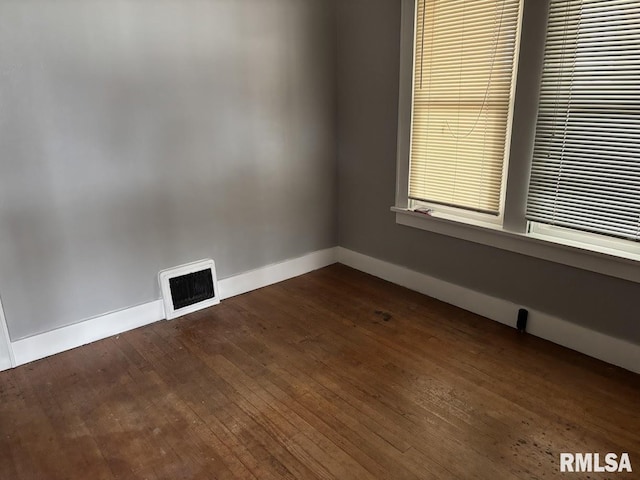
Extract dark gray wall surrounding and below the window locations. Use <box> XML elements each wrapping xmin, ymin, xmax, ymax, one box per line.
<box><xmin>337</xmin><ymin>0</ymin><xmax>640</xmax><ymax>343</ymax></box>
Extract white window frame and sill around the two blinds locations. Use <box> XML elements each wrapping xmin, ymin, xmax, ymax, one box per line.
<box><xmin>391</xmin><ymin>0</ymin><xmax>640</xmax><ymax>283</ymax></box>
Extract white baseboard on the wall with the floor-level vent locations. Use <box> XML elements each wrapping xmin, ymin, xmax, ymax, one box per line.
<box><xmin>8</xmin><ymin>247</ymin><xmax>337</xmax><ymax>370</ymax></box>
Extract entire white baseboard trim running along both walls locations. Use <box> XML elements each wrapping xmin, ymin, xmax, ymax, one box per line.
<box><xmin>6</xmin><ymin>247</ymin><xmax>640</xmax><ymax>373</ymax></box>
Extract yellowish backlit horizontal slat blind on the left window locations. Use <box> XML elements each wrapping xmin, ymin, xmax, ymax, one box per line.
<box><xmin>409</xmin><ymin>0</ymin><xmax>520</xmax><ymax>214</ymax></box>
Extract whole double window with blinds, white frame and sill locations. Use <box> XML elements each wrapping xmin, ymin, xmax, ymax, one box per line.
<box><xmin>392</xmin><ymin>0</ymin><xmax>640</xmax><ymax>282</ymax></box>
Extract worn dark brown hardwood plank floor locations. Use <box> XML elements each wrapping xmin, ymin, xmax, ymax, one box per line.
<box><xmin>0</xmin><ymin>265</ymin><xmax>640</xmax><ymax>480</ymax></box>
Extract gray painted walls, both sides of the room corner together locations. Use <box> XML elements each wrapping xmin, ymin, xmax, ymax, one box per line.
<box><xmin>0</xmin><ymin>0</ymin><xmax>640</xmax><ymax>343</ymax></box>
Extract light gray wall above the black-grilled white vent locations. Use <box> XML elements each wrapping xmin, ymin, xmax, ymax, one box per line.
<box><xmin>0</xmin><ymin>0</ymin><xmax>337</xmax><ymax>340</ymax></box>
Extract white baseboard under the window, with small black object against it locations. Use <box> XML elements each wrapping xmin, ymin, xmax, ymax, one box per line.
<box><xmin>338</xmin><ymin>247</ymin><xmax>640</xmax><ymax>373</ymax></box>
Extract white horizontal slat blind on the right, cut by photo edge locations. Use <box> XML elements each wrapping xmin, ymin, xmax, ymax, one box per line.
<box><xmin>527</xmin><ymin>0</ymin><xmax>640</xmax><ymax>240</ymax></box>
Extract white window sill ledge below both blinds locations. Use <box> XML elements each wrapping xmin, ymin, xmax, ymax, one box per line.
<box><xmin>391</xmin><ymin>207</ymin><xmax>640</xmax><ymax>283</ymax></box>
